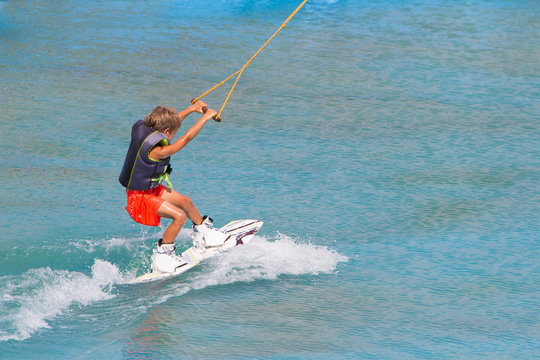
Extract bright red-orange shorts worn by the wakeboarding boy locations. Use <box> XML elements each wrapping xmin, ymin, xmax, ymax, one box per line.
<box><xmin>126</xmin><ymin>185</ymin><xmax>165</xmax><ymax>226</ymax></box>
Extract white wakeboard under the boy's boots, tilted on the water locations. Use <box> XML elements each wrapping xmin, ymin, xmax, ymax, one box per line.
<box><xmin>134</xmin><ymin>220</ymin><xmax>263</xmax><ymax>283</ymax></box>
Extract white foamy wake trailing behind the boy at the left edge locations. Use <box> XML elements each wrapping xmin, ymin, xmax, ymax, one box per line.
<box><xmin>0</xmin><ymin>259</ymin><xmax>123</xmax><ymax>341</ymax></box>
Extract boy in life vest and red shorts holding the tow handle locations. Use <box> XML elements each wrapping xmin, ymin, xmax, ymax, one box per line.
<box><xmin>118</xmin><ymin>101</ymin><xmax>228</xmax><ymax>273</ymax></box>
